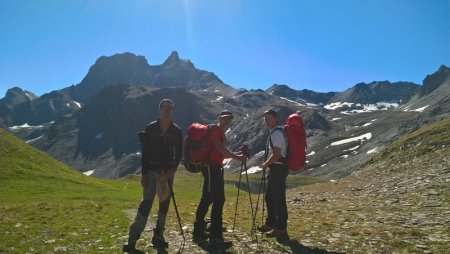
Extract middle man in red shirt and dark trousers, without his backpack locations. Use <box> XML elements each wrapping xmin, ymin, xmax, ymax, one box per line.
<box><xmin>193</xmin><ymin>110</ymin><xmax>246</xmax><ymax>247</ymax></box>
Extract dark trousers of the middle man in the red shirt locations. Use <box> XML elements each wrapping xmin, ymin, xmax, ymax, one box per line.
<box><xmin>195</xmin><ymin>166</ymin><xmax>225</xmax><ymax>238</ymax></box>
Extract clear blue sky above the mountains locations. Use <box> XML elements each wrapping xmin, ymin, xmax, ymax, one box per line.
<box><xmin>0</xmin><ymin>0</ymin><xmax>450</xmax><ymax>97</ymax></box>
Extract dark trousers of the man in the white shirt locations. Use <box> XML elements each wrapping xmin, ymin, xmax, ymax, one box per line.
<box><xmin>265</xmin><ymin>164</ymin><xmax>289</xmax><ymax>229</ymax></box>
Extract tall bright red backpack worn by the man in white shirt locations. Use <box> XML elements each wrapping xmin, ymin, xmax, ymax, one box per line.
<box><xmin>269</xmin><ymin>113</ymin><xmax>307</xmax><ymax>171</ymax></box>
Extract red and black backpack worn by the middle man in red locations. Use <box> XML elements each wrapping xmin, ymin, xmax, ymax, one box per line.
<box><xmin>184</xmin><ymin>123</ymin><xmax>218</xmax><ymax>173</ymax></box>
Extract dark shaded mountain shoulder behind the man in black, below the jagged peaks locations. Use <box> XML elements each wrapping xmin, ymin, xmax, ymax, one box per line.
<box><xmin>32</xmin><ymin>85</ymin><xmax>220</xmax><ymax>178</ymax></box>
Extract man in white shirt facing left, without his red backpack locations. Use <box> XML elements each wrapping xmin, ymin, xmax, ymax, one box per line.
<box><xmin>258</xmin><ymin>109</ymin><xmax>289</xmax><ymax>237</ymax></box>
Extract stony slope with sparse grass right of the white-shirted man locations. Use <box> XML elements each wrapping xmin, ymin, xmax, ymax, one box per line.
<box><xmin>289</xmin><ymin>119</ymin><xmax>450</xmax><ymax>253</ymax></box>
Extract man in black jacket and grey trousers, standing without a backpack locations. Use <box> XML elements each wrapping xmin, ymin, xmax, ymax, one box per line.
<box><xmin>123</xmin><ymin>99</ymin><xmax>183</xmax><ymax>252</ymax></box>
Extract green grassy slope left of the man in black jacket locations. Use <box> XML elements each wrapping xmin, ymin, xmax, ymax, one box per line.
<box><xmin>0</xmin><ymin>129</ymin><xmax>140</xmax><ymax>253</ymax></box>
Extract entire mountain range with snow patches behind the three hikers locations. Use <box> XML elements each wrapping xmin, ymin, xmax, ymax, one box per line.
<box><xmin>0</xmin><ymin>52</ymin><xmax>450</xmax><ymax>179</ymax></box>
